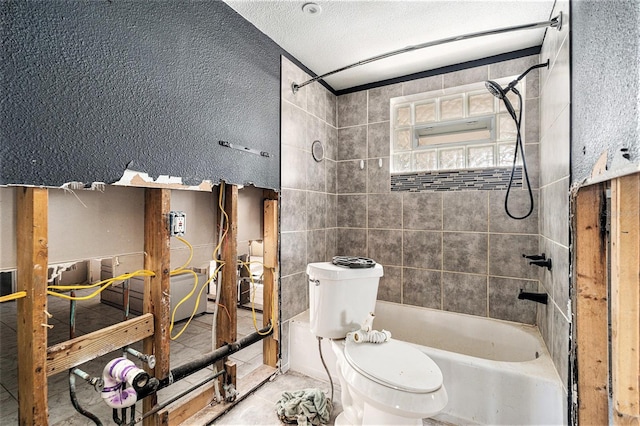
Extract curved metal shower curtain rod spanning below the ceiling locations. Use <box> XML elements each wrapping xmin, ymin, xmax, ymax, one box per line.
<box><xmin>291</xmin><ymin>12</ymin><xmax>562</xmax><ymax>93</ymax></box>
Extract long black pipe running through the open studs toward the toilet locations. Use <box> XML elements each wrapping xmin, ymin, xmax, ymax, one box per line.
<box><xmin>158</xmin><ymin>325</ymin><xmax>273</xmax><ymax>389</ymax></box>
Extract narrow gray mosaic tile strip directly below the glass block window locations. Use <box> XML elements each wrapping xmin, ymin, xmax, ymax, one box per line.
<box><xmin>391</xmin><ymin>167</ymin><xmax>522</xmax><ymax>192</ymax></box>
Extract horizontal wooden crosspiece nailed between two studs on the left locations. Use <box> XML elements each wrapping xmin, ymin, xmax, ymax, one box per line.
<box><xmin>47</xmin><ymin>313</ymin><xmax>153</xmax><ymax>376</ymax></box>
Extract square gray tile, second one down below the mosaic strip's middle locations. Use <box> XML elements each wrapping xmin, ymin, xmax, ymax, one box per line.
<box><xmin>442</xmin><ymin>232</ymin><xmax>487</xmax><ymax>274</ymax></box>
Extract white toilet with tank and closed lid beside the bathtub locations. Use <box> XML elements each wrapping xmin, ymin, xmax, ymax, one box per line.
<box><xmin>307</xmin><ymin>262</ymin><xmax>448</xmax><ymax>425</ymax></box>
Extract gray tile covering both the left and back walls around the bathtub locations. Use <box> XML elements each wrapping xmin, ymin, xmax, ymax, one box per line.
<box><xmin>281</xmin><ymin>44</ymin><xmax>568</xmax><ymax>406</ymax></box>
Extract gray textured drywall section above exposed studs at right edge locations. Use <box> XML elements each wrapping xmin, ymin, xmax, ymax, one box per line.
<box><xmin>571</xmin><ymin>0</ymin><xmax>640</xmax><ymax>182</ymax></box>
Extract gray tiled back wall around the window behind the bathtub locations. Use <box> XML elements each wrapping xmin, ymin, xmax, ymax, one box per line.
<box><xmin>336</xmin><ymin>56</ymin><xmax>540</xmax><ymax>324</ymax></box>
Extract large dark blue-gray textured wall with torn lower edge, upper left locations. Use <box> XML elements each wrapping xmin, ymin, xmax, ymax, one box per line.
<box><xmin>0</xmin><ymin>1</ymin><xmax>284</xmax><ymax>188</ymax></box>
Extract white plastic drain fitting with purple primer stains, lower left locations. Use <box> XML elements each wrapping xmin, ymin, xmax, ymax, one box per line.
<box><xmin>100</xmin><ymin>357</ymin><xmax>150</xmax><ymax>408</ymax></box>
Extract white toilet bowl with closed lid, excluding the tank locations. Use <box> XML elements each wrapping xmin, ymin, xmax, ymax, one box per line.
<box><xmin>331</xmin><ymin>339</ymin><xmax>448</xmax><ymax>425</ymax></box>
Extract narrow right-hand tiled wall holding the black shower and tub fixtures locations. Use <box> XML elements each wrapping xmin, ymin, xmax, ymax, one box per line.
<box><xmin>540</xmin><ymin>0</ymin><xmax>572</xmax><ymax>404</ymax></box>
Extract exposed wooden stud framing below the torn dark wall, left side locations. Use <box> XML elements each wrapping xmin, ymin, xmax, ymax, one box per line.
<box><xmin>6</xmin><ymin>184</ymin><xmax>279</xmax><ymax>425</ymax></box>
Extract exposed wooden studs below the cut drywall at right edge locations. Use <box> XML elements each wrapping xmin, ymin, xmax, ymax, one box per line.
<box><xmin>573</xmin><ymin>173</ymin><xmax>640</xmax><ymax>425</ymax></box>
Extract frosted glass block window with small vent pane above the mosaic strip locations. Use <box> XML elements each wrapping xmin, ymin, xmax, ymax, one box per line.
<box><xmin>391</xmin><ymin>79</ymin><xmax>526</xmax><ymax>173</ymax></box>
